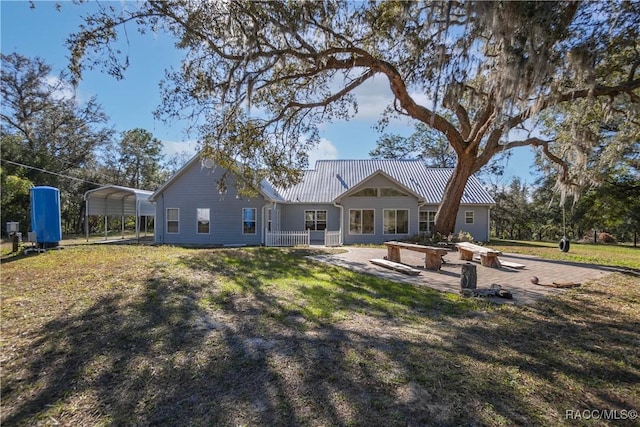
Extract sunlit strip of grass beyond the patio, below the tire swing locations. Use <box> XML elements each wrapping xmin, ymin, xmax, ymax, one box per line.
<box><xmin>487</xmin><ymin>240</ymin><xmax>640</xmax><ymax>270</ymax></box>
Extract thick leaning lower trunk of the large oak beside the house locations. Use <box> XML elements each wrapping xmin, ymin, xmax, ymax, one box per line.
<box><xmin>435</xmin><ymin>156</ymin><xmax>475</xmax><ymax>236</ymax></box>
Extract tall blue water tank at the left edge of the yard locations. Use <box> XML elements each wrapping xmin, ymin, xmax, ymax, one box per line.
<box><xmin>31</xmin><ymin>186</ymin><xmax>62</xmax><ymax>246</ymax></box>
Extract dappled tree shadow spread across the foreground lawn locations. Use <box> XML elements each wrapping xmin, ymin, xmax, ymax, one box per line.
<box><xmin>2</xmin><ymin>249</ymin><xmax>640</xmax><ymax>425</ymax></box>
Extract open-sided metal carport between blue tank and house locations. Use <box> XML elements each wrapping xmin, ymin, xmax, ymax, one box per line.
<box><xmin>84</xmin><ymin>185</ymin><xmax>156</xmax><ymax>240</ymax></box>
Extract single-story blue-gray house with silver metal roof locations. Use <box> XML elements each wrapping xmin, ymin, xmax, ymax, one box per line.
<box><xmin>149</xmin><ymin>154</ymin><xmax>495</xmax><ymax>246</ymax></box>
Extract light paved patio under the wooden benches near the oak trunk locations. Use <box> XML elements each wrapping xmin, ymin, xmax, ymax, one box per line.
<box><xmin>313</xmin><ymin>247</ymin><xmax>618</xmax><ymax>304</ymax></box>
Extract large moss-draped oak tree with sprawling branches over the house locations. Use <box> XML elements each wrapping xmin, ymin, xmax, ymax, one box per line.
<box><xmin>69</xmin><ymin>0</ymin><xmax>640</xmax><ymax>233</ymax></box>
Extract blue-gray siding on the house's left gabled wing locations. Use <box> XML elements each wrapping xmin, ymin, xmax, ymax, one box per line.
<box><xmin>155</xmin><ymin>162</ymin><xmax>267</xmax><ymax>245</ymax></box>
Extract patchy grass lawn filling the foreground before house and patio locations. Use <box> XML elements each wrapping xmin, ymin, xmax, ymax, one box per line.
<box><xmin>0</xmin><ymin>245</ymin><xmax>640</xmax><ymax>426</ymax></box>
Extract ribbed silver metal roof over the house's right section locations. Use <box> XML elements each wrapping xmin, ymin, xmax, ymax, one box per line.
<box><xmin>276</xmin><ymin>159</ymin><xmax>495</xmax><ymax>205</ymax></box>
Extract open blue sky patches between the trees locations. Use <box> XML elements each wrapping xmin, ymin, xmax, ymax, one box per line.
<box><xmin>0</xmin><ymin>0</ymin><xmax>535</xmax><ymax>184</ymax></box>
